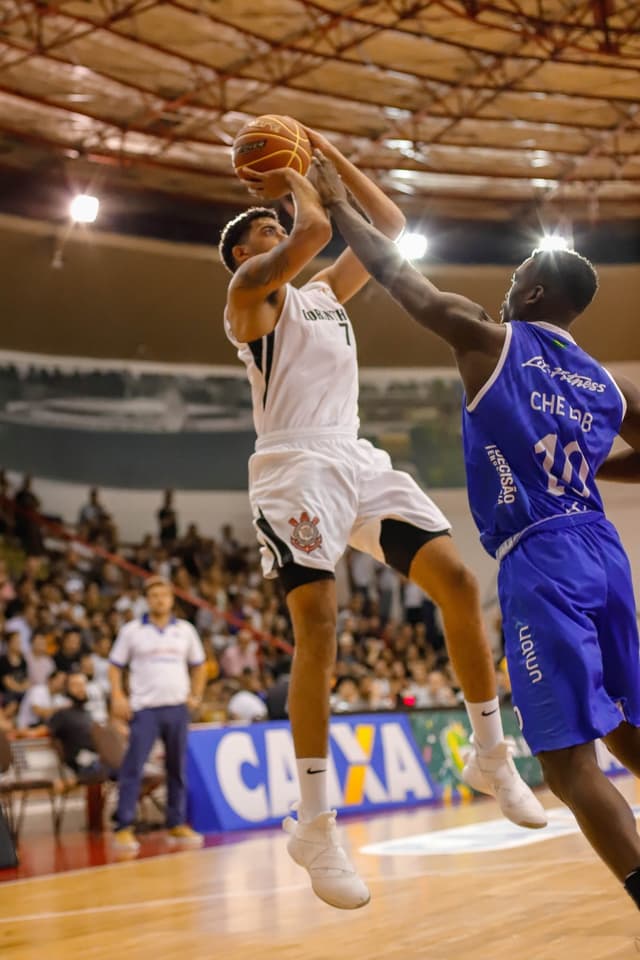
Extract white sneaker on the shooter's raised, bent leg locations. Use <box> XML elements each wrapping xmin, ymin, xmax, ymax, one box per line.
<box><xmin>462</xmin><ymin>737</ymin><xmax>548</xmax><ymax>830</ymax></box>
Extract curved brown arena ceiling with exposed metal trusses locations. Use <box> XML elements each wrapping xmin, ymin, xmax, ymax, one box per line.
<box><xmin>0</xmin><ymin>0</ymin><xmax>640</xmax><ymax>220</ymax></box>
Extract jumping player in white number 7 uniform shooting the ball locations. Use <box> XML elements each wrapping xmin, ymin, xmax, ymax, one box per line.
<box><xmin>220</xmin><ymin>130</ymin><xmax>546</xmax><ymax>909</ymax></box>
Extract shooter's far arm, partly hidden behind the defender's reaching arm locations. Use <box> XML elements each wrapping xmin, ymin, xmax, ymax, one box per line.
<box><xmin>306</xmin><ymin>128</ymin><xmax>406</xmax><ymax>303</ymax></box>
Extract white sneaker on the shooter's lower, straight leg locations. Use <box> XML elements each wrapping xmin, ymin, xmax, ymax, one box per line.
<box><xmin>282</xmin><ymin>807</ymin><xmax>371</xmax><ymax>910</ymax></box>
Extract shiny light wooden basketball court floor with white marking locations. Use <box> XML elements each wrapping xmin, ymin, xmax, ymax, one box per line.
<box><xmin>0</xmin><ymin>778</ymin><xmax>640</xmax><ymax>960</ymax></box>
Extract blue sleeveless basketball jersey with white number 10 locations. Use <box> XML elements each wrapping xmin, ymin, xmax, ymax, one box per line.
<box><xmin>463</xmin><ymin>322</ymin><xmax>626</xmax><ymax>558</ymax></box>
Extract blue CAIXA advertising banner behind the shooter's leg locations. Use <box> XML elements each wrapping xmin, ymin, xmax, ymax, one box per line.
<box><xmin>187</xmin><ymin>714</ymin><xmax>439</xmax><ymax>833</ymax></box>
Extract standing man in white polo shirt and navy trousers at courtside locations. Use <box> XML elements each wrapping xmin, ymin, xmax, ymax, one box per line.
<box><xmin>109</xmin><ymin>576</ymin><xmax>206</xmax><ymax>855</ymax></box>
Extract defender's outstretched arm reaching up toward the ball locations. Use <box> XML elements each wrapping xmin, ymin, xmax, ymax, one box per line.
<box><xmin>312</xmin><ymin>151</ymin><xmax>505</xmax><ymax>397</ymax></box>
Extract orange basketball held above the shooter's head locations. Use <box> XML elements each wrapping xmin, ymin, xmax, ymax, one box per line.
<box><xmin>233</xmin><ymin>115</ymin><xmax>311</xmax><ymax>177</ymax></box>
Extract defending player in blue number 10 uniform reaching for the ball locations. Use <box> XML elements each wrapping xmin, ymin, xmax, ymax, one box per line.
<box><xmin>311</xmin><ymin>151</ymin><xmax>640</xmax><ymax>907</ymax></box>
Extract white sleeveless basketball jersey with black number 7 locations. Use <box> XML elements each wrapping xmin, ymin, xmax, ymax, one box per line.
<box><xmin>224</xmin><ymin>281</ymin><xmax>359</xmax><ymax>437</ymax></box>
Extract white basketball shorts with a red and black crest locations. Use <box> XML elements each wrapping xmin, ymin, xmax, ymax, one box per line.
<box><xmin>249</xmin><ymin>430</ymin><xmax>451</xmax><ymax>577</ymax></box>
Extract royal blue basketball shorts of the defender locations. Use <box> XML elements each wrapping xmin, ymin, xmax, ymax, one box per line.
<box><xmin>498</xmin><ymin>517</ymin><xmax>640</xmax><ymax>754</ymax></box>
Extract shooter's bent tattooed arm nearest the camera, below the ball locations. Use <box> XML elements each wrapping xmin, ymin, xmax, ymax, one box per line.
<box><xmin>227</xmin><ymin>169</ymin><xmax>331</xmax><ymax>343</ymax></box>
